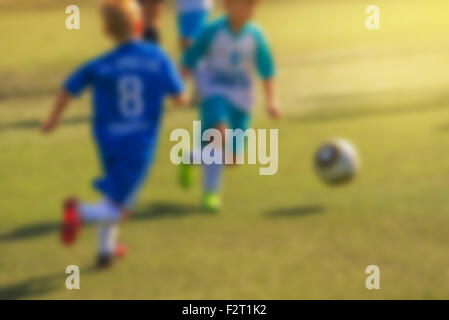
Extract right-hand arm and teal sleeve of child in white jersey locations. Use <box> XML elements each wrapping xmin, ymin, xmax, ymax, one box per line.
<box><xmin>256</xmin><ymin>31</ymin><xmax>280</xmax><ymax>118</ymax></box>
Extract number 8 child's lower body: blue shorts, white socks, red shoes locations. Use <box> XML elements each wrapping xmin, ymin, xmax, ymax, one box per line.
<box><xmin>62</xmin><ymin>141</ymin><xmax>153</xmax><ymax>267</ymax></box>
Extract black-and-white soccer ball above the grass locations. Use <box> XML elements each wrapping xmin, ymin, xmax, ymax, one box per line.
<box><xmin>315</xmin><ymin>139</ymin><xmax>360</xmax><ymax>185</ymax></box>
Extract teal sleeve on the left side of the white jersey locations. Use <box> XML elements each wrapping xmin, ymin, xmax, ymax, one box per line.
<box><xmin>182</xmin><ymin>20</ymin><xmax>217</xmax><ymax>70</ymax></box>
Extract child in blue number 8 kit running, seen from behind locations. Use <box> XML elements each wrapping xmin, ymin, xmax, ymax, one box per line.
<box><xmin>42</xmin><ymin>0</ymin><xmax>183</xmax><ymax>267</ymax></box>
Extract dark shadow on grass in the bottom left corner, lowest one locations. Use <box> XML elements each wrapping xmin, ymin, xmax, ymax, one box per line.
<box><xmin>0</xmin><ymin>267</ymin><xmax>98</xmax><ymax>300</ymax></box>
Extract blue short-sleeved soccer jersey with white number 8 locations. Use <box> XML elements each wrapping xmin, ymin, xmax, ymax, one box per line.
<box><xmin>64</xmin><ymin>41</ymin><xmax>183</xmax><ymax>136</ymax></box>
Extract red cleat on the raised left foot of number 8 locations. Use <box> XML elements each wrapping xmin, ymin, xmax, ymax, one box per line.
<box><xmin>61</xmin><ymin>198</ymin><xmax>81</xmax><ymax>246</ymax></box>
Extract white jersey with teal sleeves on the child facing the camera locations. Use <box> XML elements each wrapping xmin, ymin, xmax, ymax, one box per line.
<box><xmin>183</xmin><ymin>17</ymin><xmax>275</xmax><ymax>111</ymax></box>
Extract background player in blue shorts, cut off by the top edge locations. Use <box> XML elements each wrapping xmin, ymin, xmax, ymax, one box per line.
<box><xmin>176</xmin><ymin>0</ymin><xmax>213</xmax><ymax>52</ymax></box>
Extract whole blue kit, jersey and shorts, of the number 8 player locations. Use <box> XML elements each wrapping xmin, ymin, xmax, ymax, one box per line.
<box><xmin>64</xmin><ymin>41</ymin><xmax>183</xmax><ymax>207</ymax></box>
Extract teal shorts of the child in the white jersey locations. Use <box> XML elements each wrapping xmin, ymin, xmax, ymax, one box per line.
<box><xmin>200</xmin><ymin>96</ymin><xmax>251</xmax><ymax>155</ymax></box>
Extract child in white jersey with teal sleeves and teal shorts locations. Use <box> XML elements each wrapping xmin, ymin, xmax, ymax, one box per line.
<box><xmin>180</xmin><ymin>0</ymin><xmax>279</xmax><ymax>210</ymax></box>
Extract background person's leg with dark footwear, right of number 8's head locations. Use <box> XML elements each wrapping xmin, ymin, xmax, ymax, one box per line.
<box><xmin>139</xmin><ymin>0</ymin><xmax>164</xmax><ymax>44</ymax></box>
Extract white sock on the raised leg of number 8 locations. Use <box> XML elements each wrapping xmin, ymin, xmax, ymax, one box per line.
<box><xmin>79</xmin><ymin>199</ymin><xmax>121</xmax><ymax>222</ymax></box>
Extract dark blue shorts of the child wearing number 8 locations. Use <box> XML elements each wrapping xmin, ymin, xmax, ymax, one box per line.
<box><xmin>94</xmin><ymin>131</ymin><xmax>156</xmax><ymax>209</ymax></box>
